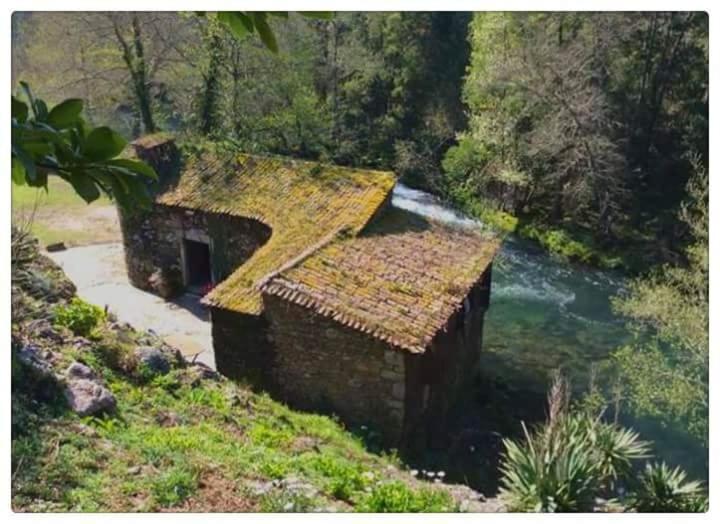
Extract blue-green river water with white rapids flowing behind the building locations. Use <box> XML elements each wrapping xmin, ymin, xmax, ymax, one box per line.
<box><xmin>393</xmin><ymin>184</ymin><xmax>707</xmax><ymax>484</ymax></box>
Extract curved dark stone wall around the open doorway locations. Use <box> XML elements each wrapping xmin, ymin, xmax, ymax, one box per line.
<box><xmin>120</xmin><ymin>204</ymin><xmax>271</xmax><ymax>297</ymax></box>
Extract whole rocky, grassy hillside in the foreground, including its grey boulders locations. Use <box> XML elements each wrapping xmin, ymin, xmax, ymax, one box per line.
<box><xmin>12</xmin><ymin>231</ymin><xmax>499</xmax><ymax>512</ymax></box>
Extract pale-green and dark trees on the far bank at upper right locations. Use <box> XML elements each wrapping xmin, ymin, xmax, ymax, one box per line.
<box><xmin>444</xmin><ymin>12</ymin><xmax>708</xmax><ymax>267</ymax></box>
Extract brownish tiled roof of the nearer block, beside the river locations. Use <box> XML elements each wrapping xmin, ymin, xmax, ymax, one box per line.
<box><xmin>264</xmin><ymin>208</ymin><xmax>500</xmax><ymax>353</ymax></box>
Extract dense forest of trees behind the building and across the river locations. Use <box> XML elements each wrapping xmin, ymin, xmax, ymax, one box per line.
<box><xmin>13</xmin><ymin>12</ymin><xmax>708</xmax><ymax>273</ymax></box>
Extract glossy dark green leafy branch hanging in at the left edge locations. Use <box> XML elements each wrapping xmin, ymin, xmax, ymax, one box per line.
<box><xmin>12</xmin><ymin>82</ymin><xmax>157</xmax><ymax>207</ymax></box>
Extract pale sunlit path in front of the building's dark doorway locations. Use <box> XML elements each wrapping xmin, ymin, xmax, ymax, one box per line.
<box><xmin>48</xmin><ymin>243</ymin><xmax>215</xmax><ymax>369</ymax></box>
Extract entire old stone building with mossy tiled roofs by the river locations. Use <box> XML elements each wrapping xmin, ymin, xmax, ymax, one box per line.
<box><xmin>121</xmin><ymin>135</ymin><xmax>499</xmax><ymax>445</ymax></box>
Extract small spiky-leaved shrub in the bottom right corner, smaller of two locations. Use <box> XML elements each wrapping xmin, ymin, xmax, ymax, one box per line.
<box><xmin>629</xmin><ymin>462</ymin><xmax>708</xmax><ymax>513</ymax></box>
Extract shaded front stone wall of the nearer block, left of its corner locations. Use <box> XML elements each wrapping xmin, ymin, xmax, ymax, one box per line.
<box><xmin>263</xmin><ymin>295</ymin><xmax>405</xmax><ymax>444</ymax></box>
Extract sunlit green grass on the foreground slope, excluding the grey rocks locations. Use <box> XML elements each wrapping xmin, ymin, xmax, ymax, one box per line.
<box><xmin>12</xmin><ymin>294</ymin><xmax>455</xmax><ymax>512</ymax></box>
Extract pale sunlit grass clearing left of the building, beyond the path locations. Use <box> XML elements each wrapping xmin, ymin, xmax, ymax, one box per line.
<box><xmin>12</xmin><ymin>177</ymin><xmax>120</xmax><ymax>246</ymax></box>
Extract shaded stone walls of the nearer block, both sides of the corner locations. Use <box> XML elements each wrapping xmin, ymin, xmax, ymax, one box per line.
<box><xmin>212</xmin><ymin>269</ymin><xmax>490</xmax><ymax>448</ymax></box>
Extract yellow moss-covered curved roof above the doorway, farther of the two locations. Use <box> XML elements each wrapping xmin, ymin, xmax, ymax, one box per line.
<box><xmin>156</xmin><ymin>153</ymin><xmax>395</xmax><ymax>314</ymax></box>
